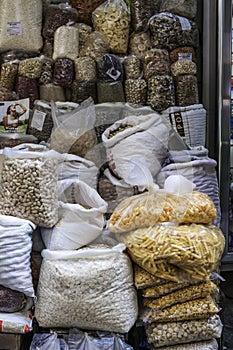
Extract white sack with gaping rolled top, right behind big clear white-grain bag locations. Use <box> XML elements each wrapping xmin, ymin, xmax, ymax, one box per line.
<box><xmin>41</xmin><ymin>179</ymin><xmax>107</xmax><ymax>250</ymax></box>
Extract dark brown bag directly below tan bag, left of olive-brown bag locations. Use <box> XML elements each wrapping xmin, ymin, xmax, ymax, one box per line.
<box><xmin>71</xmin><ymin>80</ymin><xmax>97</xmax><ymax>103</ymax></box>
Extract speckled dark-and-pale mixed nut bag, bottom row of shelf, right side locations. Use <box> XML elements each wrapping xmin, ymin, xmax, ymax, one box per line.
<box><xmin>147</xmin><ymin>75</ymin><xmax>175</xmax><ymax>112</ymax></box>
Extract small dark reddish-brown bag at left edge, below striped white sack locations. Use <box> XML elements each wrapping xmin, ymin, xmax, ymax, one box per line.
<box><xmin>0</xmin><ymin>285</ymin><xmax>26</xmax><ymax>312</ymax></box>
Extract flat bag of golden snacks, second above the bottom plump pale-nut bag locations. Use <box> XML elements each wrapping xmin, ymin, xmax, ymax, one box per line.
<box><xmin>143</xmin><ymin>281</ymin><xmax>217</xmax><ymax>310</ymax></box>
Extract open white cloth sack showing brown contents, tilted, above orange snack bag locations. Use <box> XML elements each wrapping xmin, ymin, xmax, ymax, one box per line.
<box><xmin>102</xmin><ymin>112</ymin><xmax>169</xmax><ymax>186</ymax></box>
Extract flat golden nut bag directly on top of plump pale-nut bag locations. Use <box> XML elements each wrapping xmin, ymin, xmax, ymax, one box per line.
<box><xmin>140</xmin><ymin>296</ymin><xmax>219</xmax><ymax>323</ymax></box>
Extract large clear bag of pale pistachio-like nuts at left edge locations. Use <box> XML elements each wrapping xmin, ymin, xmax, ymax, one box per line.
<box><xmin>0</xmin><ymin>148</ymin><xmax>59</xmax><ymax>227</ymax></box>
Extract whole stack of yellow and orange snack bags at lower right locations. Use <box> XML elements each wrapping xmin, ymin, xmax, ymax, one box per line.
<box><xmin>109</xmin><ymin>176</ymin><xmax>225</xmax><ymax>349</ymax></box>
